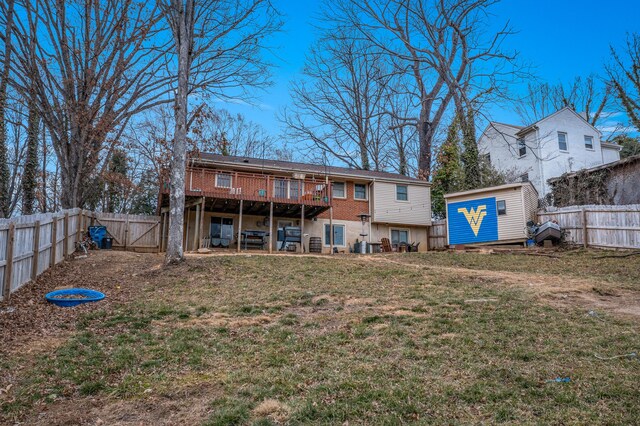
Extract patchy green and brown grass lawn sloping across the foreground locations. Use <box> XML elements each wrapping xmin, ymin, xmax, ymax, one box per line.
<box><xmin>0</xmin><ymin>251</ymin><xmax>640</xmax><ymax>425</ymax></box>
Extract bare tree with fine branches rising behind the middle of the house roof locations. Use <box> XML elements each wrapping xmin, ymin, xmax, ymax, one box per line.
<box><xmin>281</xmin><ymin>30</ymin><xmax>392</xmax><ymax>170</ymax></box>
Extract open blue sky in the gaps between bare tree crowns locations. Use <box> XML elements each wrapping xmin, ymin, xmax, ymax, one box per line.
<box><xmin>219</xmin><ymin>0</ymin><xmax>640</xmax><ymax>136</ymax></box>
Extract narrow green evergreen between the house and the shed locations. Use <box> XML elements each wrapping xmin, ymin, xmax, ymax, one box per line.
<box><xmin>431</xmin><ymin>117</ymin><xmax>465</xmax><ymax>218</ymax></box>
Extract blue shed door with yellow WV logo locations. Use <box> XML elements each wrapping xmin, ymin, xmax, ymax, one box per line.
<box><xmin>447</xmin><ymin>197</ymin><xmax>498</xmax><ymax>245</ymax></box>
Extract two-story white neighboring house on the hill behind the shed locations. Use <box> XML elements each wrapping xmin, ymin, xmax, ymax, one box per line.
<box><xmin>478</xmin><ymin>107</ymin><xmax>621</xmax><ymax>197</ymax></box>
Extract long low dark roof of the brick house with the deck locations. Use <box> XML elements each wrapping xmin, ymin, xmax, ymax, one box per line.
<box><xmin>192</xmin><ymin>153</ymin><xmax>431</xmax><ymax>186</ymax></box>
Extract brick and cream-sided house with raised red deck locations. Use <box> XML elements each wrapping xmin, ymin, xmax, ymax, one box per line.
<box><xmin>159</xmin><ymin>153</ymin><xmax>431</xmax><ymax>253</ymax></box>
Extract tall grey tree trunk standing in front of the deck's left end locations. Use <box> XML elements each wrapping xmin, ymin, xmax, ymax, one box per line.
<box><xmin>166</xmin><ymin>2</ymin><xmax>190</xmax><ymax>263</ymax></box>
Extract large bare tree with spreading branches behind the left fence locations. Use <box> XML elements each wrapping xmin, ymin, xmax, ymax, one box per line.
<box><xmin>14</xmin><ymin>0</ymin><xmax>172</xmax><ymax>207</ymax></box>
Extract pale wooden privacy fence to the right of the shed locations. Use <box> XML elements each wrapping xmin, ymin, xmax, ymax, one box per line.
<box><xmin>538</xmin><ymin>204</ymin><xmax>640</xmax><ymax>249</ymax></box>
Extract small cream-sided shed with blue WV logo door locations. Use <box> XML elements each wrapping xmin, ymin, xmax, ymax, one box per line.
<box><xmin>444</xmin><ymin>182</ymin><xmax>538</xmax><ymax>246</ymax></box>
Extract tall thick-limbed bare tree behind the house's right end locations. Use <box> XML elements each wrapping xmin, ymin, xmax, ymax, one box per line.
<box><xmin>339</xmin><ymin>0</ymin><xmax>514</xmax><ymax>179</ymax></box>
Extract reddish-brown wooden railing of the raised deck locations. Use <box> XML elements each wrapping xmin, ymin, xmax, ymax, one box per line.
<box><xmin>162</xmin><ymin>168</ymin><xmax>331</xmax><ymax>207</ymax></box>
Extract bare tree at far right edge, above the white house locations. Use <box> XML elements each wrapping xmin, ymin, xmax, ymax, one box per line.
<box><xmin>606</xmin><ymin>33</ymin><xmax>640</xmax><ymax>131</ymax></box>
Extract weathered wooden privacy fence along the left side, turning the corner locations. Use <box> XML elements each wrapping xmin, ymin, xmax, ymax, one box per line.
<box><xmin>0</xmin><ymin>209</ymin><xmax>160</xmax><ymax>300</ymax></box>
